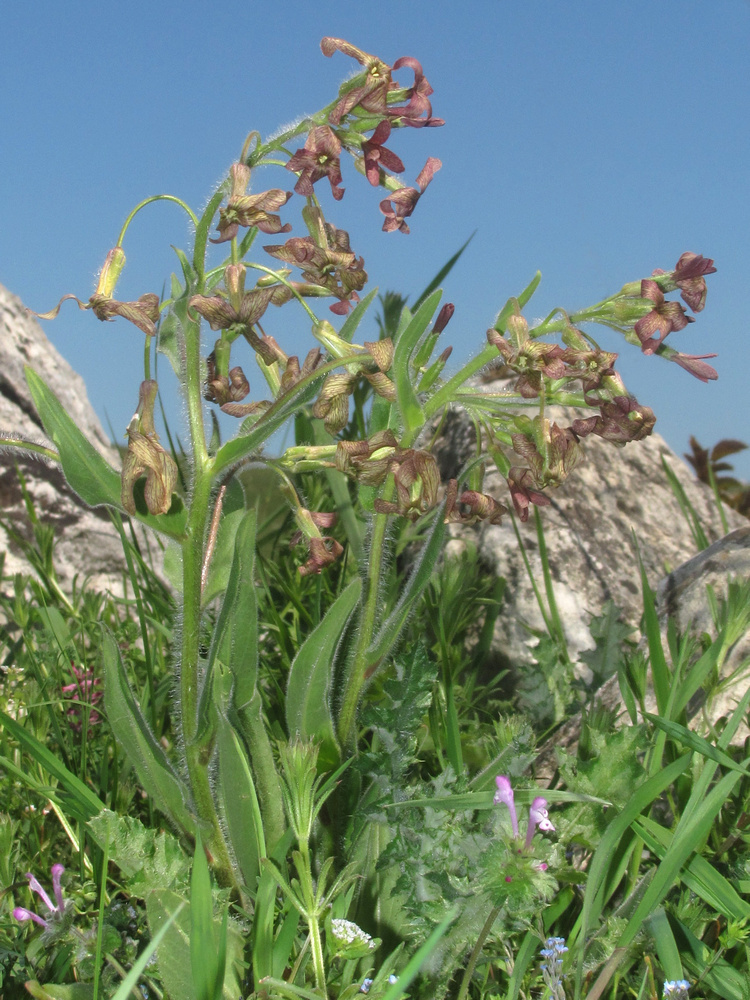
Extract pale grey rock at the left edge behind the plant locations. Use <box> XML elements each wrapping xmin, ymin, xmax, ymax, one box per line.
<box><xmin>0</xmin><ymin>285</ymin><xmax>159</xmax><ymax>594</ymax></box>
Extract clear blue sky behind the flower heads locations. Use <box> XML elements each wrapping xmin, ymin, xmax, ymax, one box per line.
<box><xmin>0</xmin><ymin>0</ymin><xmax>750</xmax><ymax>478</ymax></box>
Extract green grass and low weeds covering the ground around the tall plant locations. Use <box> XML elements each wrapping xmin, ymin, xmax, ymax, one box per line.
<box><xmin>0</xmin><ymin>456</ymin><xmax>750</xmax><ymax>1000</ymax></box>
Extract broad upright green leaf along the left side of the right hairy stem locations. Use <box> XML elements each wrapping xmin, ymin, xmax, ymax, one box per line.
<box><xmin>286</xmin><ymin>577</ymin><xmax>362</xmax><ymax>769</ymax></box>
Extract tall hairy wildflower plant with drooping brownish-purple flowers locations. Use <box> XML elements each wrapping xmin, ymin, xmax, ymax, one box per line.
<box><xmin>0</xmin><ymin>29</ymin><xmax>728</xmax><ymax>998</ymax></box>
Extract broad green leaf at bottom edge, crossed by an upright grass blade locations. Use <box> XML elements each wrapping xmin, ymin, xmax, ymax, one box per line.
<box><xmin>146</xmin><ymin>889</ymin><xmax>244</xmax><ymax>1000</ymax></box>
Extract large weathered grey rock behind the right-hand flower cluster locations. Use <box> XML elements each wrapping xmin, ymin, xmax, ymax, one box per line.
<box><xmin>435</xmin><ymin>386</ymin><xmax>748</xmax><ymax>671</ymax></box>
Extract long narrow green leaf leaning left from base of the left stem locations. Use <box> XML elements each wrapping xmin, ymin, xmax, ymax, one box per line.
<box><xmin>97</xmin><ymin>628</ymin><xmax>196</xmax><ymax>835</ymax></box>
